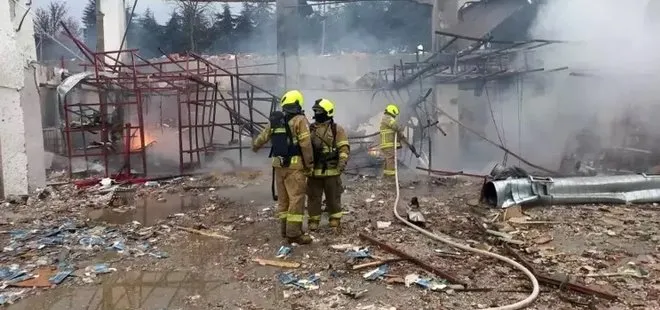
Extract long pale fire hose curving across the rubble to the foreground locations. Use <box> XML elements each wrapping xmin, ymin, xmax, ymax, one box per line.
<box><xmin>393</xmin><ymin>133</ymin><xmax>539</xmax><ymax>310</ymax></box>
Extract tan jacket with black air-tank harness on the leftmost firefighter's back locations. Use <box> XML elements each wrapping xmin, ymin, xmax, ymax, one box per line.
<box><xmin>252</xmin><ymin>112</ymin><xmax>314</xmax><ymax>170</ymax></box>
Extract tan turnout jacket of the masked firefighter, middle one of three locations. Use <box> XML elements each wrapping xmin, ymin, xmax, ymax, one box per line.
<box><xmin>310</xmin><ymin>120</ymin><xmax>350</xmax><ymax>177</ymax></box>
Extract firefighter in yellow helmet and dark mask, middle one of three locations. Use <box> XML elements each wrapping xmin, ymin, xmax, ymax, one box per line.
<box><xmin>307</xmin><ymin>99</ymin><xmax>350</xmax><ymax>232</ymax></box>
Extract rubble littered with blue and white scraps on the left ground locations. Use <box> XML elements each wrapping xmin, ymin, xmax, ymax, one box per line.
<box><xmin>0</xmin><ymin>171</ymin><xmax>259</xmax><ymax>304</ymax></box>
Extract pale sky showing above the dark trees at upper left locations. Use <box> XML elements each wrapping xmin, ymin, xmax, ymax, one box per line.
<box><xmin>33</xmin><ymin>0</ymin><xmax>240</xmax><ymax>24</ymax></box>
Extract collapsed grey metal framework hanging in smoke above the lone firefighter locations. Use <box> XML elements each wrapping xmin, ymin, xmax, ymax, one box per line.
<box><xmin>361</xmin><ymin>25</ymin><xmax>568</xmax><ymax>176</ymax></box>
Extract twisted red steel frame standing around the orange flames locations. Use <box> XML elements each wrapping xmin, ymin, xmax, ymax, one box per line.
<box><xmin>58</xmin><ymin>25</ymin><xmax>279</xmax><ymax>177</ymax></box>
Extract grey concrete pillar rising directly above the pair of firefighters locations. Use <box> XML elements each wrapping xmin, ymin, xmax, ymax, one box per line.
<box><xmin>275</xmin><ymin>0</ymin><xmax>301</xmax><ymax>89</ymax></box>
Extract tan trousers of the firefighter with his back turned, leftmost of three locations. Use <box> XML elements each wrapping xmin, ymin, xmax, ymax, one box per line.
<box><xmin>275</xmin><ymin>168</ymin><xmax>307</xmax><ymax>238</ymax></box>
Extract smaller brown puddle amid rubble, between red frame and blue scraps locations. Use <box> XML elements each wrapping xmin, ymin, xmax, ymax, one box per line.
<box><xmin>88</xmin><ymin>194</ymin><xmax>203</xmax><ymax>226</ymax></box>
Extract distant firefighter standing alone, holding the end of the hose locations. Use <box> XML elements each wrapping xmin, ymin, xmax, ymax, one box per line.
<box><xmin>380</xmin><ymin>104</ymin><xmax>417</xmax><ymax>178</ymax></box>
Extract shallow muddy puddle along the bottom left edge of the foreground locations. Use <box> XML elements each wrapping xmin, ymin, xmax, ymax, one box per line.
<box><xmin>8</xmin><ymin>271</ymin><xmax>223</xmax><ymax>310</ymax></box>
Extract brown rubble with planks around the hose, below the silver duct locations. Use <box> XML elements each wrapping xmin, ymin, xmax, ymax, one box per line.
<box><xmin>238</xmin><ymin>174</ymin><xmax>660</xmax><ymax>309</ymax></box>
